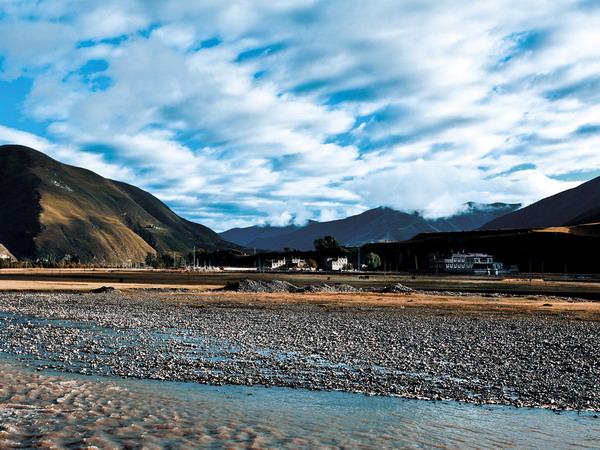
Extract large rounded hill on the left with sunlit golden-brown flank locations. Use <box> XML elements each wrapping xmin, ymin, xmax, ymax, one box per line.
<box><xmin>0</xmin><ymin>145</ymin><xmax>239</xmax><ymax>264</ymax></box>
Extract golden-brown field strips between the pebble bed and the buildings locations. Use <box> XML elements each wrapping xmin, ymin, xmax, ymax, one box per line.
<box><xmin>0</xmin><ymin>269</ymin><xmax>600</xmax><ymax>320</ymax></box>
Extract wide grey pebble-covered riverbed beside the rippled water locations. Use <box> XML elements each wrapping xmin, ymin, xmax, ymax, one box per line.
<box><xmin>0</xmin><ymin>292</ymin><xmax>600</xmax><ymax>410</ymax></box>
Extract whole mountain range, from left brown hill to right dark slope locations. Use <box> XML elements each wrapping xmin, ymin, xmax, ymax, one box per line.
<box><xmin>0</xmin><ymin>145</ymin><xmax>600</xmax><ymax>266</ymax></box>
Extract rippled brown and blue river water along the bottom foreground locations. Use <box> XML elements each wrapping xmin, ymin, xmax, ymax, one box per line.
<box><xmin>0</xmin><ymin>359</ymin><xmax>600</xmax><ymax>448</ymax></box>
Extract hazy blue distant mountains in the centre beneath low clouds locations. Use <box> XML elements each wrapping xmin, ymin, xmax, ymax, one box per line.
<box><xmin>221</xmin><ymin>202</ymin><xmax>521</xmax><ymax>250</ymax></box>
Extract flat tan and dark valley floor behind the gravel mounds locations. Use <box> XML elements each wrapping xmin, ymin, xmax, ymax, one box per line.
<box><xmin>0</xmin><ymin>269</ymin><xmax>600</xmax><ymax>301</ymax></box>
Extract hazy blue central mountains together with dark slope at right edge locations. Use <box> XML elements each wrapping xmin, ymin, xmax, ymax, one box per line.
<box><xmin>221</xmin><ymin>177</ymin><xmax>600</xmax><ymax>250</ymax></box>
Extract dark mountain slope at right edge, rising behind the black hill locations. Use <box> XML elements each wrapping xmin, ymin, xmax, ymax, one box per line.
<box><xmin>481</xmin><ymin>177</ymin><xmax>600</xmax><ymax>230</ymax></box>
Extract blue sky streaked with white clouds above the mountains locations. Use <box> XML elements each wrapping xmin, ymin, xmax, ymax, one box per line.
<box><xmin>0</xmin><ymin>0</ymin><xmax>600</xmax><ymax>231</ymax></box>
